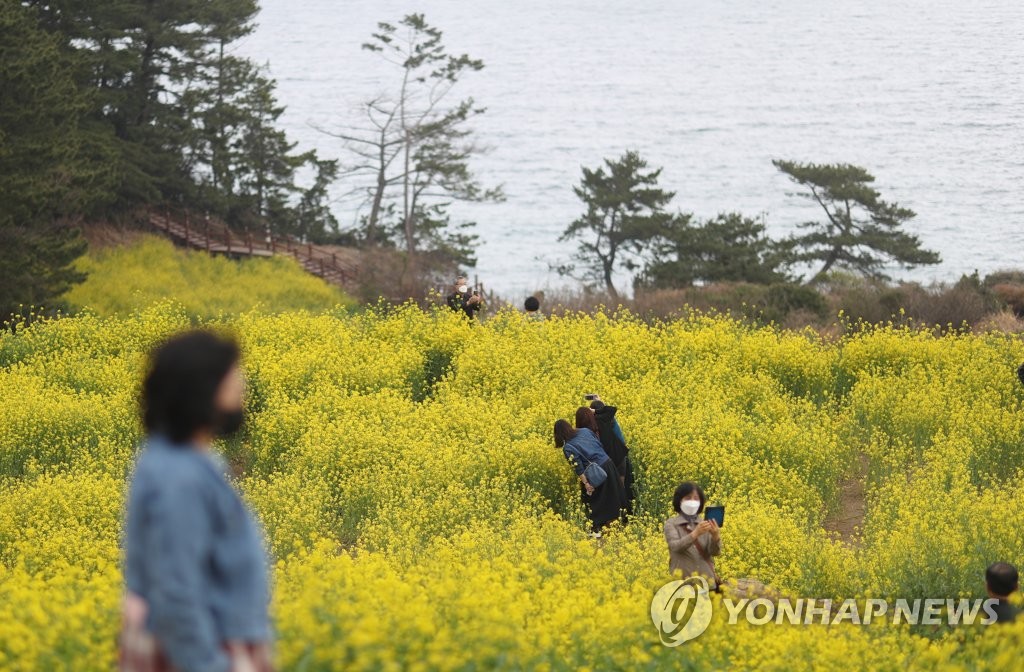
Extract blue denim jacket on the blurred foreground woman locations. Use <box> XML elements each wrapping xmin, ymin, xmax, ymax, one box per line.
<box><xmin>124</xmin><ymin>436</ymin><xmax>270</xmax><ymax>672</ymax></box>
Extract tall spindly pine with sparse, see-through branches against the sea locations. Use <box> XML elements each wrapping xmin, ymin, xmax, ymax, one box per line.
<box><xmin>330</xmin><ymin>14</ymin><xmax>504</xmax><ymax>265</ymax></box>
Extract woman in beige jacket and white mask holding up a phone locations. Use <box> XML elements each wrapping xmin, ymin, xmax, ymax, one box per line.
<box><xmin>665</xmin><ymin>480</ymin><xmax>722</xmax><ymax>590</ymax></box>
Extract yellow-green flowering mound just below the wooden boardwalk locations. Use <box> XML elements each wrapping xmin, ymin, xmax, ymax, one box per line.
<box><xmin>65</xmin><ymin>236</ymin><xmax>351</xmax><ymax>318</ymax></box>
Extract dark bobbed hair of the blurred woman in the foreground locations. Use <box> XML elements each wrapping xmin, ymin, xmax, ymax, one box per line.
<box><xmin>142</xmin><ymin>331</ymin><xmax>241</xmax><ymax>445</ymax></box>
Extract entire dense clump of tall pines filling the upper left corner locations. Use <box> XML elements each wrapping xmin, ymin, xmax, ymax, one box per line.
<box><xmin>0</xmin><ymin>0</ymin><xmax>337</xmax><ymax>318</ymax></box>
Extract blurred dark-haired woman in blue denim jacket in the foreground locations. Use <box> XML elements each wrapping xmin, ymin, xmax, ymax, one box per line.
<box><xmin>121</xmin><ymin>331</ymin><xmax>271</xmax><ymax>672</ymax></box>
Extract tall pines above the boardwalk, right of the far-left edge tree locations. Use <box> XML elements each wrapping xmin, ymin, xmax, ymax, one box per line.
<box><xmin>12</xmin><ymin>0</ymin><xmax>326</xmax><ymax>230</ymax></box>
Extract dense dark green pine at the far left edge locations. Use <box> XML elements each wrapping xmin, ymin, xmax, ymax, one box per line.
<box><xmin>0</xmin><ymin>2</ymin><xmax>117</xmax><ymax>320</ymax></box>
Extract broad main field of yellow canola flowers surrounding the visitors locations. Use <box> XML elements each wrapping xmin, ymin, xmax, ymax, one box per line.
<box><xmin>0</xmin><ymin>303</ymin><xmax>1024</xmax><ymax>671</ymax></box>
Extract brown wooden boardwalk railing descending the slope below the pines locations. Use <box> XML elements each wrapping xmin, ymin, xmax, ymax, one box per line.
<box><xmin>147</xmin><ymin>210</ymin><xmax>358</xmax><ymax>286</ymax></box>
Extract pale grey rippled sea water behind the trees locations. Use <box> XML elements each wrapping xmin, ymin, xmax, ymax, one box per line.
<box><xmin>241</xmin><ymin>0</ymin><xmax>1024</xmax><ymax>293</ymax></box>
